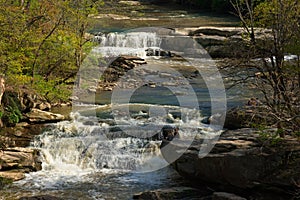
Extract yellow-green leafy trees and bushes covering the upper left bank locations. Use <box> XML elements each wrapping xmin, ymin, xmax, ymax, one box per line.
<box><xmin>0</xmin><ymin>0</ymin><xmax>103</xmax><ymax>100</ymax></box>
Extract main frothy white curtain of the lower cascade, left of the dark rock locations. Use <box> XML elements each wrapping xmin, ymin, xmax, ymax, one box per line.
<box><xmin>34</xmin><ymin>114</ymin><xmax>159</xmax><ymax>170</ymax></box>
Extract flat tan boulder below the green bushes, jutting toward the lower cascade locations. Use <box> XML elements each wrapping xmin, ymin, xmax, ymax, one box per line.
<box><xmin>26</xmin><ymin>108</ymin><xmax>65</xmax><ymax>123</ymax></box>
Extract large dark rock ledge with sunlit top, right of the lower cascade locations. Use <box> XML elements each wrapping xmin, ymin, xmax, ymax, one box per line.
<box><xmin>173</xmin><ymin>128</ymin><xmax>300</xmax><ymax>194</ymax></box>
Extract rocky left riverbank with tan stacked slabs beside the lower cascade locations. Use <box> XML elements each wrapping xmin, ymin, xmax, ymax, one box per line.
<box><xmin>0</xmin><ymin>88</ymin><xmax>65</xmax><ymax>185</ymax></box>
